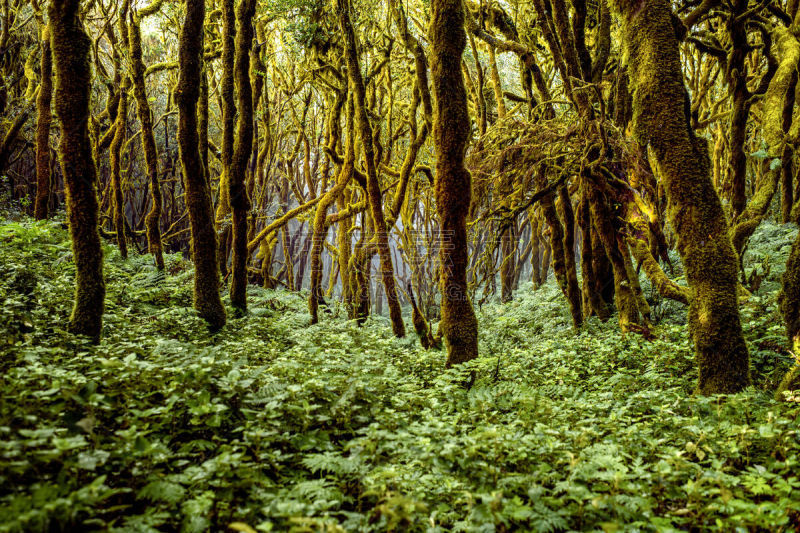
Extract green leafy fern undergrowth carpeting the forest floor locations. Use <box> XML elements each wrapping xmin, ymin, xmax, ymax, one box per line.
<box><xmin>0</xmin><ymin>214</ymin><xmax>800</xmax><ymax>532</ymax></box>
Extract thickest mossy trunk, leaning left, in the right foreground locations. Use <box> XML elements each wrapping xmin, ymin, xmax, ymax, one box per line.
<box><xmin>613</xmin><ymin>0</ymin><xmax>750</xmax><ymax>394</ymax></box>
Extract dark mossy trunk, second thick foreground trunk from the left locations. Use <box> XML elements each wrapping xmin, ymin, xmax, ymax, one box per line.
<box><xmin>175</xmin><ymin>0</ymin><xmax>226</xmax><ymax>329</ymax></box>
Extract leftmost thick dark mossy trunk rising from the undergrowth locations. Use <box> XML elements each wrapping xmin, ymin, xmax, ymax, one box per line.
<box><xmin>48</xmin><ymin>0</ymin><xmax>106</xmax><ymax>340</ymax></box>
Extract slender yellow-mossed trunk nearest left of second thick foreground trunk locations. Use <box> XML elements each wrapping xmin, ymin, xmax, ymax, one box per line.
<box><xmin>128</xmin><ymin>7</ymin><xmax>164</xmax><ymax>270</ymax></box>
